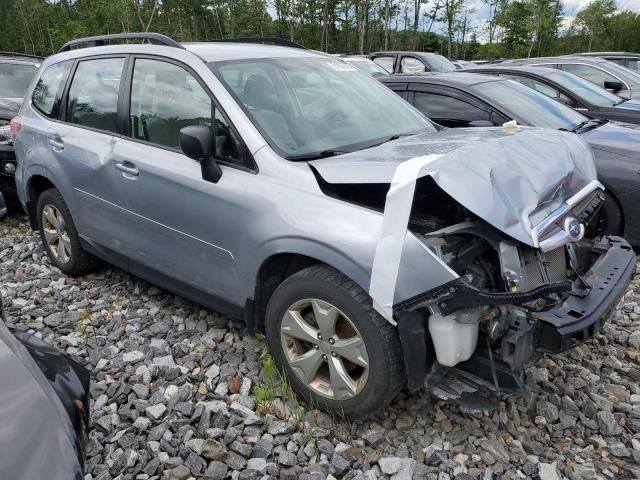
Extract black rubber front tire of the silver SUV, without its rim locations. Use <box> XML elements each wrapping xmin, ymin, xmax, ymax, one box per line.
<box><xmin>265</xmin><ymin>265</ymin><xmax>405</xmax><ymax>418</ymax></box>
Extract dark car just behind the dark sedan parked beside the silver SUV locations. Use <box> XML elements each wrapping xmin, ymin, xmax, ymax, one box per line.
<box><xmin>467</xmin><ymin>65</ymin><xmax>640</xmax><ymax>124</ymax></box>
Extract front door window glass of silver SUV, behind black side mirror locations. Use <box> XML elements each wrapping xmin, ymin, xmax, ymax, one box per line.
<box><xmin>129</xmin><ymin>59</ymin><xmax>211</xmax><ymax>150</ymax></box>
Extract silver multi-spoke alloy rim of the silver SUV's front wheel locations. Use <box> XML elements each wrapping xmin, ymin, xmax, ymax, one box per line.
<box><xmin>280</xmin><ymin>299</ymin><xmax>369</xmax><ymax>400</ymax></box>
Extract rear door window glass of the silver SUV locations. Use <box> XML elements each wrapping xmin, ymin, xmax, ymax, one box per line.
<box><xmin>67</xmin><ymin>58</ymin><xmax>125</xmax><ymax>133</ymax></box>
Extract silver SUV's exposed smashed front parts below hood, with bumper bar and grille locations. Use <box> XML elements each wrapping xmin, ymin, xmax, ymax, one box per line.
<box><xmin>393</xmin><ymin>184</ymin><xmax>636</xmax><ymax>408</ymax></box>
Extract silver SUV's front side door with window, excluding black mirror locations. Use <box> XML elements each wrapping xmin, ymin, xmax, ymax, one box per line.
<box><xmin>114</xmin><ymin>56</ymin><xmax>256</xmax><ymax>311</ymax></box>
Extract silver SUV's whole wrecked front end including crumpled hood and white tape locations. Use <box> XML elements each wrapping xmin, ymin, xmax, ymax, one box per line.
<box><xmin>313</xmin><ymin>129</ymin><xmax>636</xmax><ymax>408</ymax></box>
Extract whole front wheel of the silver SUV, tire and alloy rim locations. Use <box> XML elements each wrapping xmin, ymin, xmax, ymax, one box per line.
<box><xmin>266</xmin><ymin>265</ymin><xmax>404</xmax><ymax>418</ymax></box>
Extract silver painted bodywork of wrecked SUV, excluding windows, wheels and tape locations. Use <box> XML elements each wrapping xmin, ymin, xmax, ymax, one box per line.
<box><xmin>16</xmin><ymin>44</ymin><xmax>595</xmax><ymax>322</ymax></box>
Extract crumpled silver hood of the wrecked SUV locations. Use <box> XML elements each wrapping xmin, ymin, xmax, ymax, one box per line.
<box><xmin>310</xmin><ymin>127</ymin><xmax>596</xmax><ymax>246</ymax></box>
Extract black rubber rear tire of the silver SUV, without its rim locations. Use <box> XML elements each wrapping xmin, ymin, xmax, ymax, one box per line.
<box><xmin>36</xmin><ymin>188</ymin><xmax>99</xmax><ymax>277</ymax></box>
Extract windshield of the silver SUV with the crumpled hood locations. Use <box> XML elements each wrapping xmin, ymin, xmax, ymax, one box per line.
<box><xmin>210</xmin><ymin>57</ymin><xmax>436</xmax><ymax>159</ymax></box>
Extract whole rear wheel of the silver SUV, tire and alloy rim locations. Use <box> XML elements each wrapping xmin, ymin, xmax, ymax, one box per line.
<box><xmin>36</xmin><ymin>188</ymin><xmax>98</xmax><ymax>276</ymax></box>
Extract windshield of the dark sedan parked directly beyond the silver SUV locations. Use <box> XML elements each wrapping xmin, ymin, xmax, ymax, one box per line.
<box><xmin>472</xmin><ymin>80</ymin><xmax>587</xmax><ymax>130</ymax></box>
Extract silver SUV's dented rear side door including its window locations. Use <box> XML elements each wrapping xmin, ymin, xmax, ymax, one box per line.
<box><xmin>48</xmin><ymin>55</ymin><xmax>130</xmax><ymax>268</ymax></box>
